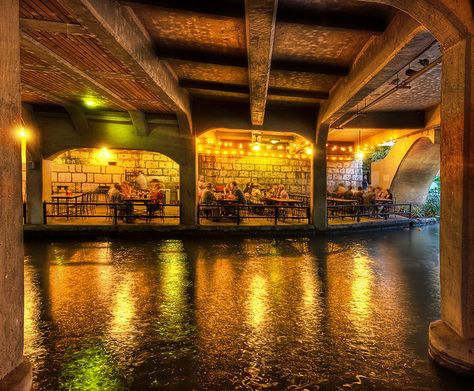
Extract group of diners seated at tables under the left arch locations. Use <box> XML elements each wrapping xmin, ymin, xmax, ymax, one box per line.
<box><xmin>107</xmin><ymin>174</ymin><xmax>166</xmax><ymax>223</ymax></box>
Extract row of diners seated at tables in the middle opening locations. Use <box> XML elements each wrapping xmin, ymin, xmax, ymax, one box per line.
<box><xmin>198</xmin><ymin>176</ymin><xmax>290</xmax><ymax>205</ymax></box>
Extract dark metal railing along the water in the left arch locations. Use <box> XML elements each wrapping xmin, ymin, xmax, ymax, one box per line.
<box><xmin>43</xmin><ymin>202</ymin><xmax>181</xmax><ymax>224</ymax></box>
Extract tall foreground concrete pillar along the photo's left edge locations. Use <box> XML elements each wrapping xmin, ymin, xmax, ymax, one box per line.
<box><xmin>0</xmin><ymin>0</ymin><xmax>31</xmax><ymax>390</ymax></box>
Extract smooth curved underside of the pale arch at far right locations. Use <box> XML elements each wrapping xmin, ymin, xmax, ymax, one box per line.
<box><xmin>391</xmin><ymin>137</ymin><xmax>440</xmax><ymax>204</ymax></box>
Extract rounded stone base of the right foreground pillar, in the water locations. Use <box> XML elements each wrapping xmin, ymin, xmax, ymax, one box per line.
<box><xmin>428</xmin><ymin>320</ymin><xmax>474</xmax><ymax>376</ymax></box>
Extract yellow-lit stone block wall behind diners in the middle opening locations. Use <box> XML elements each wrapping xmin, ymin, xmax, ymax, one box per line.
<box><xmin>198</xmin><ymin>154</ymin><xmax>311</xmax><ymax>195</ymax></box>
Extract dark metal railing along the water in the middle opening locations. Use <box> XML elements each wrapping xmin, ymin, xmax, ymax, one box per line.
<box><xmin>197</xmin><ymin>204</ymin><xmax>311</xmax><ymax>225</ymax></box>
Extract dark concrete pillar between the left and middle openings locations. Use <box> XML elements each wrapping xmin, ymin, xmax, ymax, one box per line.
<box><xmin>179</xmin><ymin>136</ymin><xmax>197</xmax><ymax>225</ymax></box>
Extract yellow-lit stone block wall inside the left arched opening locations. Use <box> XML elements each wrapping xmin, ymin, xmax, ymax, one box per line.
<box><xmin>51</xmin><ymin>149</ymin><xmax>179</xmax><ymax>193</ymax></box>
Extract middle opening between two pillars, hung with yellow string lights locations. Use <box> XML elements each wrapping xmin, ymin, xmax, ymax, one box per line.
<box><xmin>197</xmin><ymin>129</ymin><xmax>313</xmax><ymax>225</ymax></box>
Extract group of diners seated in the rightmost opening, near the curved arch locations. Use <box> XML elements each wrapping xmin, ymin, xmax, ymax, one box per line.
<box><xmin>327</xmin><ymin>183</ymin><xmax>393</xmax><ymax>205</ymax></box>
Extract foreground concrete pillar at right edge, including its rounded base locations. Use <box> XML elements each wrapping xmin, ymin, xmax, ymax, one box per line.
<box><xmin>429</xmin><ymin>39</ymin><xmax>474</xmax><ymax>373</ymax></box>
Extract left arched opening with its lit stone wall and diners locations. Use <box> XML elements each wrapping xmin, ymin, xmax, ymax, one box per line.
<box><xmin>43</xmin><ymin>148</ymin><xmax>180</xmax><ymax>224</ymax></box>
